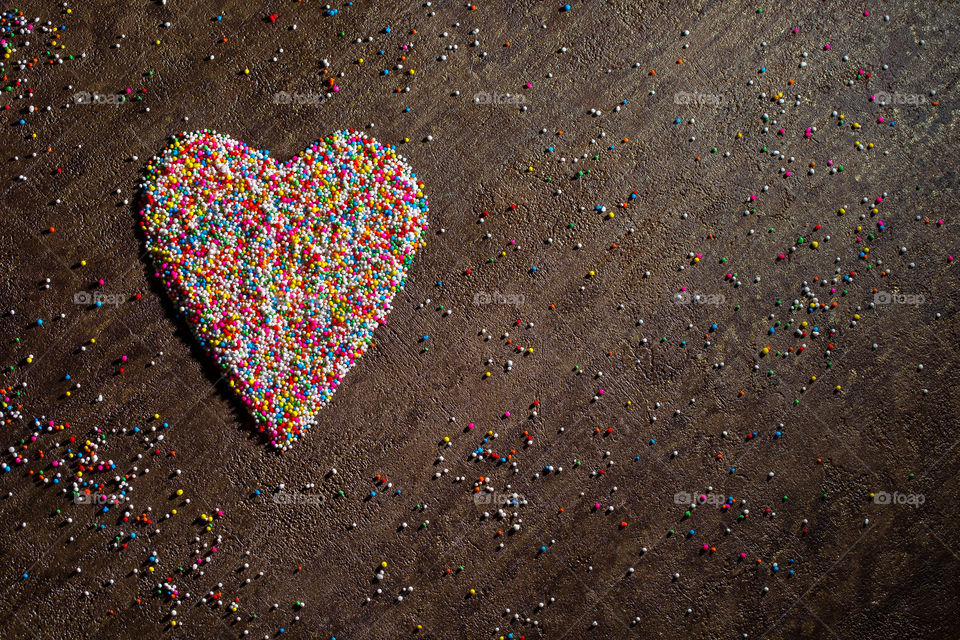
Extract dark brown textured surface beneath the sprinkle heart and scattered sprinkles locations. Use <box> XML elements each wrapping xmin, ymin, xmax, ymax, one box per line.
<box><xmin>0</xmin><ymin>0</ymin><xmax>960</xmax><ymax>639</ymax></box>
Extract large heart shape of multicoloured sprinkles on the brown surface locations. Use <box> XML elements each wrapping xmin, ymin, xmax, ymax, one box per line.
<box><xmin>140</xmin><ymin>130</ymin><xmax>428</xmax><ymax>449</ymax></box>
